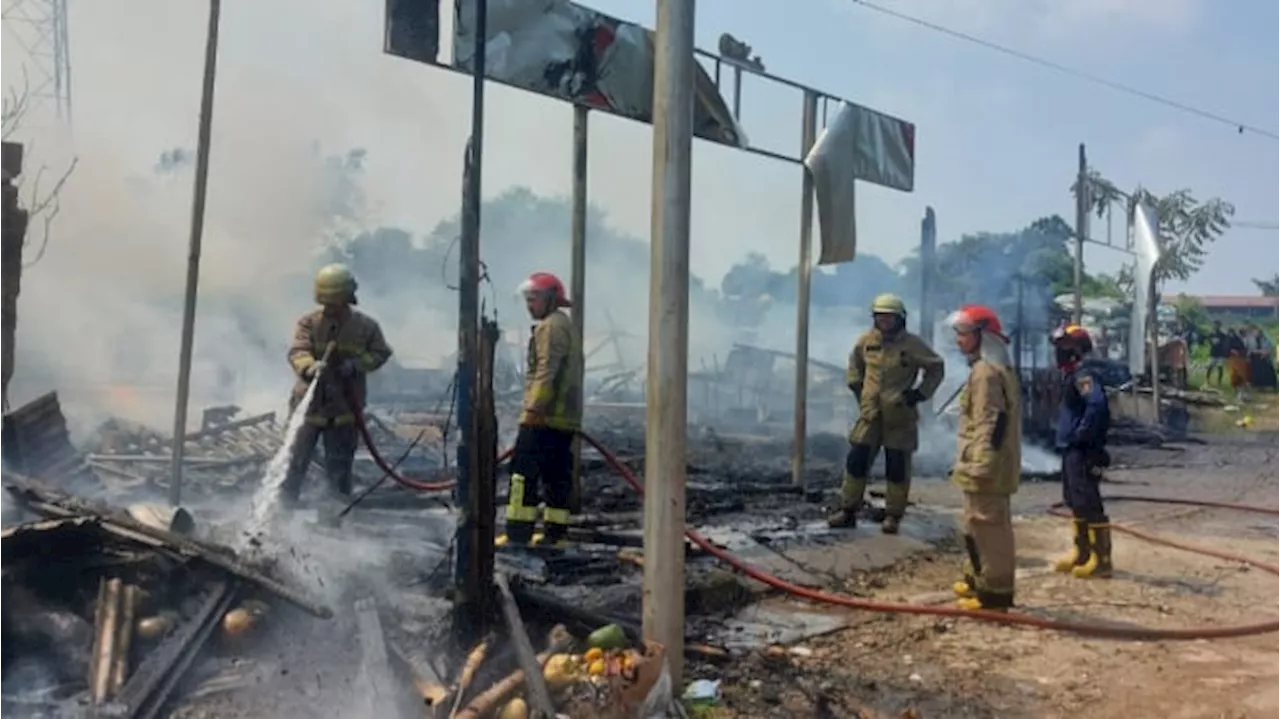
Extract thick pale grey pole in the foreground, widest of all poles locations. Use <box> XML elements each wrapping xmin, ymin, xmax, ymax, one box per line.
<box><xmin>643</xmin><ymin>0</ymin><xmax>695</xmax><ymax>687</ymax></box>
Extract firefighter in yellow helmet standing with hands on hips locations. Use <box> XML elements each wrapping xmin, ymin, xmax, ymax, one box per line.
<box><xmin>827</xmin><ymin>294</ymin><xmax>945</xmax><ymax>535</ymax></box>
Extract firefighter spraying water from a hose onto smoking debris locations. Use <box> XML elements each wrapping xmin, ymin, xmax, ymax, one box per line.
<box><xmin>280</xmin><ymin>265</ymin><xmax>392</xmax><ymax>504</ymax></box>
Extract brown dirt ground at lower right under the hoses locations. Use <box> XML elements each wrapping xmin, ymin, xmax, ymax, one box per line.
<box><xmin>689</xmin><ymin>432</ymin><xmax>1280</xmax><ymax>719</ymax></box>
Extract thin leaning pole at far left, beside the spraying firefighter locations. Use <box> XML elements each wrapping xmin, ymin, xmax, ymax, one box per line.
<box><xmin>169</xmin><ymin>0</ymin><xmax>223</xmax><ymax>507</ymax></box>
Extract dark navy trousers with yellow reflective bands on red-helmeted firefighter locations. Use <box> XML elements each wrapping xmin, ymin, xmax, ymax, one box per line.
<box><xmin>507</xmin><ymin>426</ymin><xmax>573</xmax><ymax>544</ymax></box>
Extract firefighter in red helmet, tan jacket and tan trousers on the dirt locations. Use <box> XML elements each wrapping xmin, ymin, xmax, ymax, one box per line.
<box><xmin>948</xmin><ymin>304</ymin><xmax>1023</xmax><ymax>610</ymax></box>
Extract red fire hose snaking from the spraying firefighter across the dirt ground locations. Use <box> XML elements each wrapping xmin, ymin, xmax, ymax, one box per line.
<box><xmin>345</xmin><ymin>411</ymin><xmax>1280</xmax><ymax>641</ymax></box>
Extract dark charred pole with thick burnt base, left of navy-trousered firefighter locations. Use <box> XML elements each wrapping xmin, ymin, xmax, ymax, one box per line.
<box><xmin>454</xmin><ymin>0</ymin><xmax>494</xmax><ymax>631</ymax></box>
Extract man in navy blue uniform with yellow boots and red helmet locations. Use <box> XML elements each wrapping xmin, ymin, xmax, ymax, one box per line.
<box><xmin>1052</xmin><ymin>325</ymin><xmax>1111</xmax><ymax>578</ymax></box>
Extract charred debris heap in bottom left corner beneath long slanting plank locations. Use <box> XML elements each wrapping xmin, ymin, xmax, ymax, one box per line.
<box><xmin>0</xmin><ymin>472</ymin><xmax>330</xmax><ymax>718</ymax></box>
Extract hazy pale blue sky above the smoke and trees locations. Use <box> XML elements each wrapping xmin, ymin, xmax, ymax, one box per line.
<box><xmin>0</xmin><ymin>0</ymin><xmax>1280</xmax><ymax>293</ymax></box>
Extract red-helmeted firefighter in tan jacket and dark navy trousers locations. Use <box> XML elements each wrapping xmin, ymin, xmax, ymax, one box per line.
<box><xmin>495</xmin><ymin>273</ymin><xmax>582</xmax><ymax>546</ymax></box>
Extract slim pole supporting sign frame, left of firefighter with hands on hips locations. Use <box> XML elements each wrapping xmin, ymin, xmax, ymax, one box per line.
<box><xmin>791</xmin><ymin>90</ymin><xmax>818</xmax><ymax>486</ymax></box>
